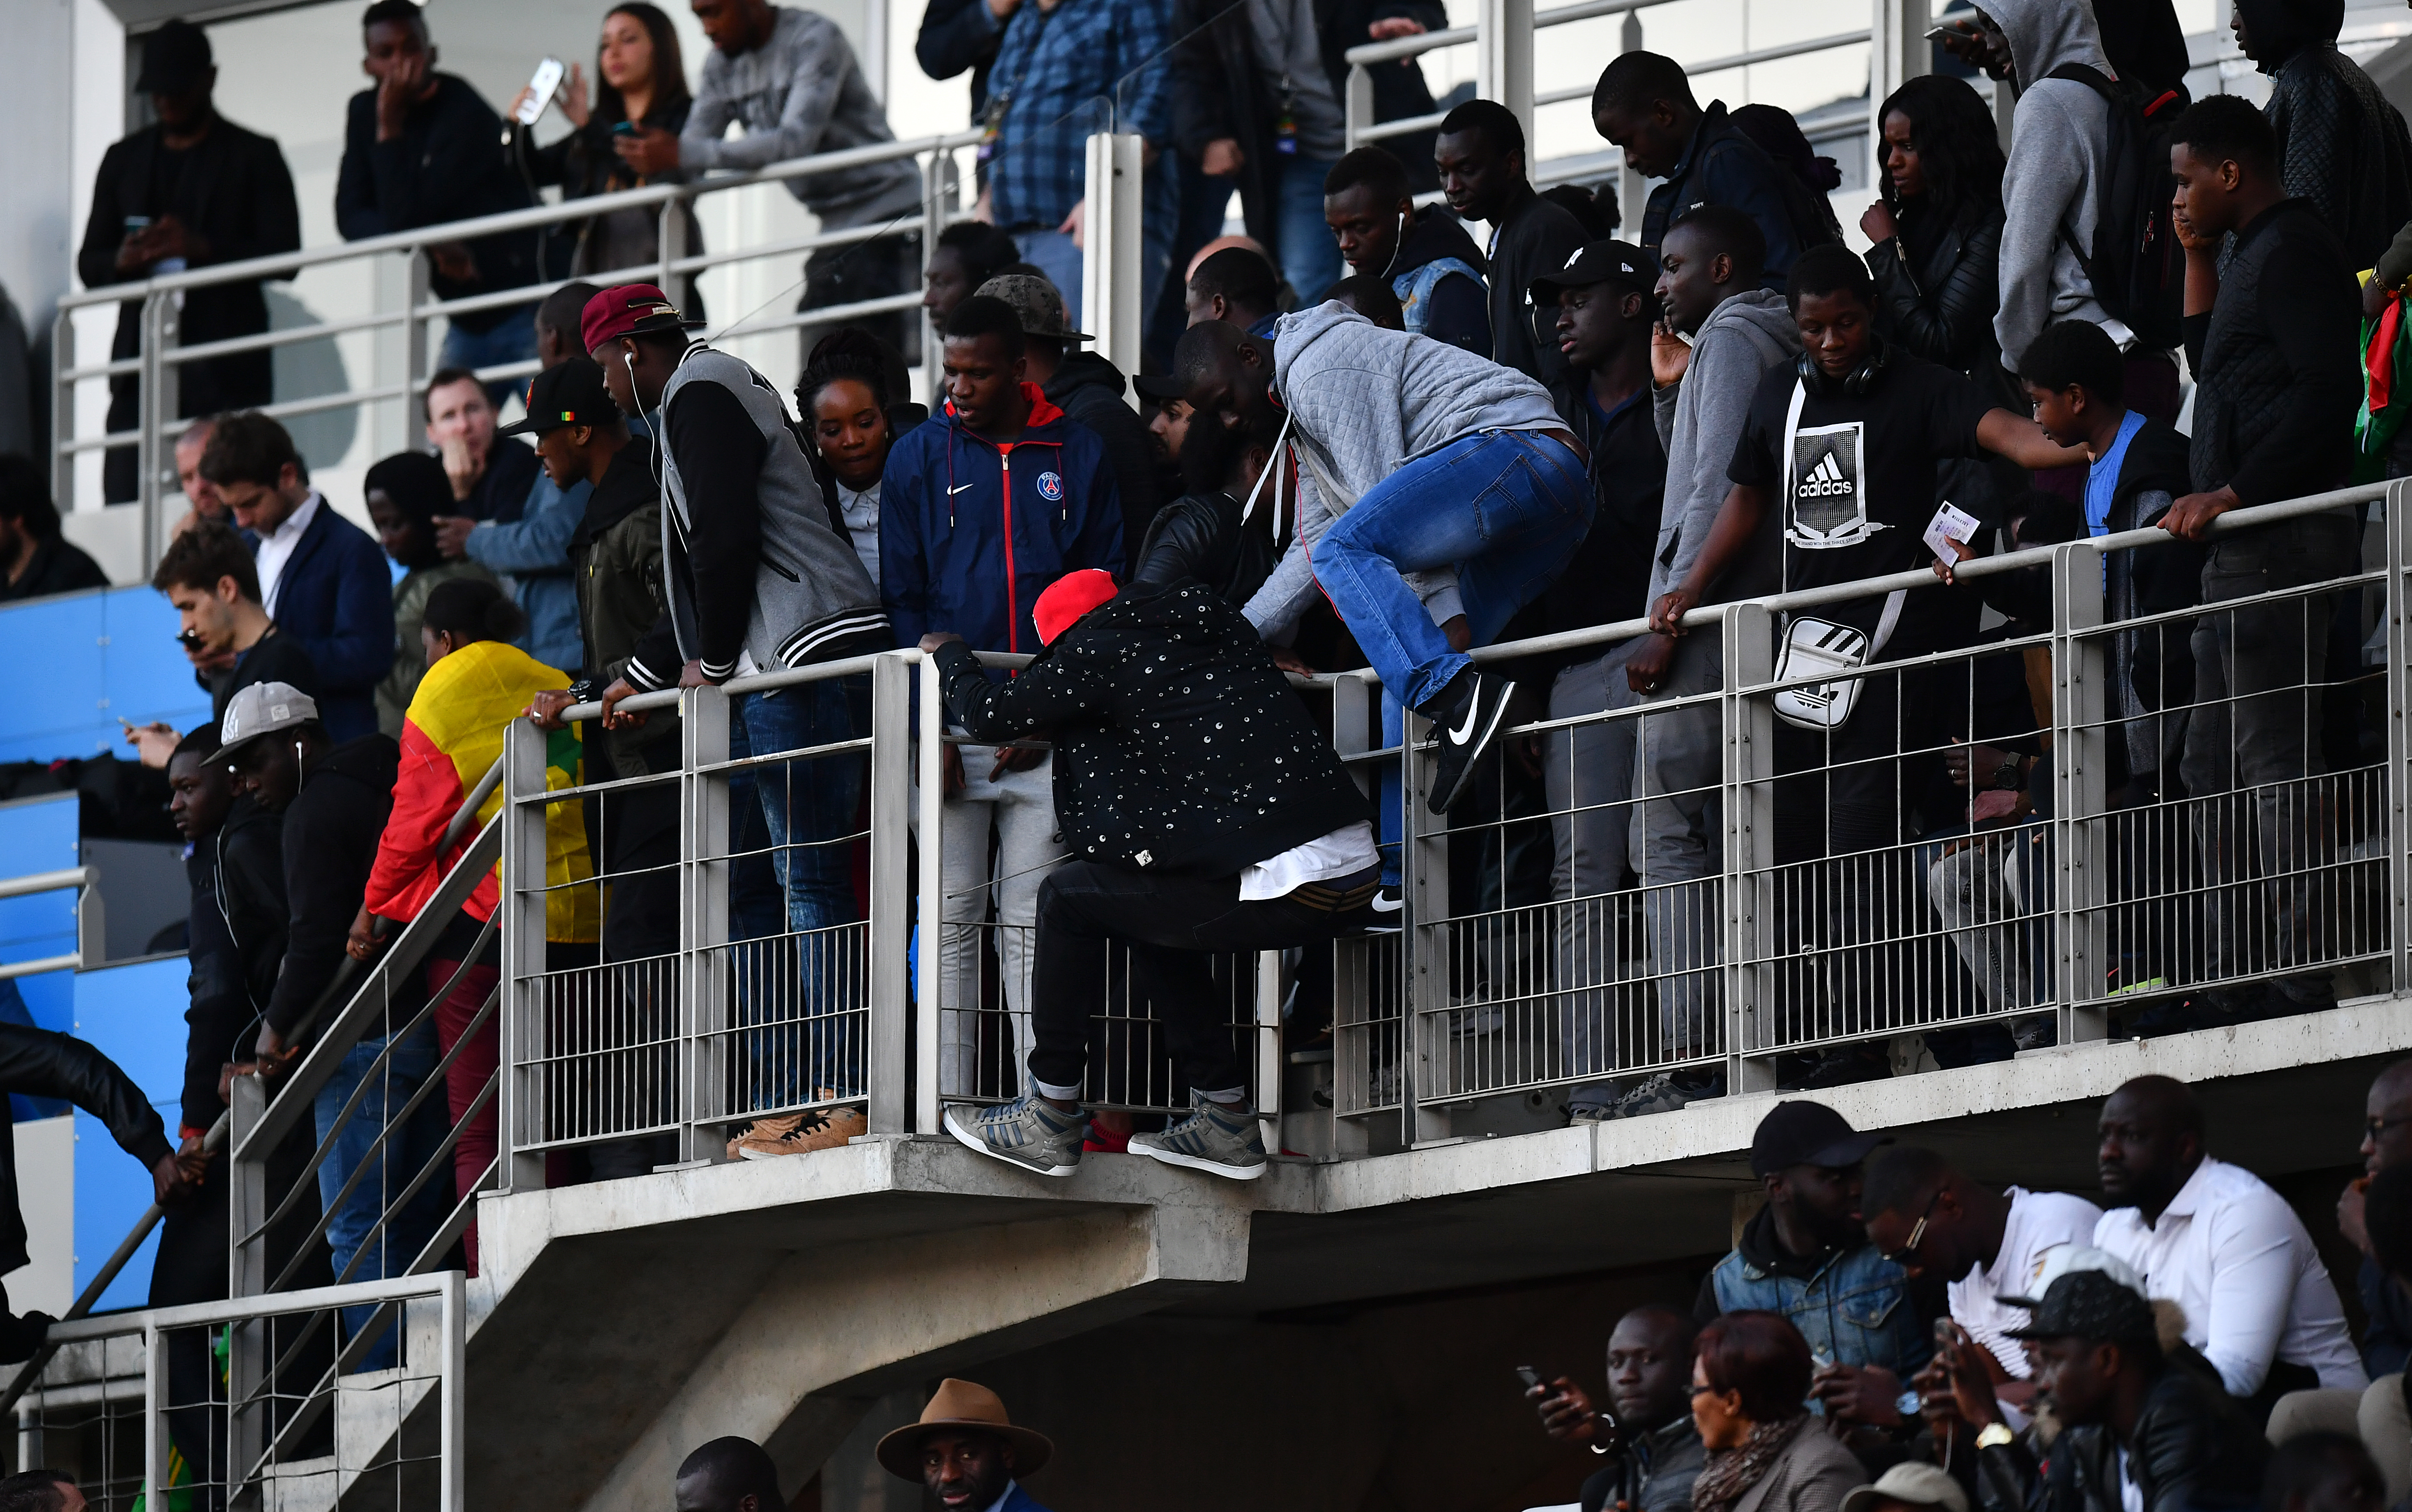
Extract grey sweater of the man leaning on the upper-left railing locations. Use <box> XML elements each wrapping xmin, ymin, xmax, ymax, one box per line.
<box><xmin>678</xmin><ymin>7</ymin><xmax>922</xmax><ymax>229</ymax></box>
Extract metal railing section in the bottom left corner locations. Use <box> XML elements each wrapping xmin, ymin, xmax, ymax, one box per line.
<box><xmin>15</xmin><ymin>1271</ymin><xmax>468</xmax><ymax>1512</ymax></box>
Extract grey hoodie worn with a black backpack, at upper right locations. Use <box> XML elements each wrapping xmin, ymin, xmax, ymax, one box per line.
<box><xmin>1976</xmin><ymin>0</ymin><xmax>2132</xmax><ymax>371</ymax></box>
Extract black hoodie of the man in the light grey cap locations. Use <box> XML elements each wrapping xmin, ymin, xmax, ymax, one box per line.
<box><xmin>268</xmin><ymin>735</ymin><xmax>403</xmax><ymax>1037</ymax></box>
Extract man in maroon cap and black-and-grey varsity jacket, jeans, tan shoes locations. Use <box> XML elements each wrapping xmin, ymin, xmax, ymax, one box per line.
<box><xmin>584</xmin><ymin>285</ymin><xmax>890</xmax><ymax>1158</ymax></box>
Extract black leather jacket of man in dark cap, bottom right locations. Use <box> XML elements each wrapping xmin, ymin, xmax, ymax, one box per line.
<box><xmin>1978</xmin><ymin>1351</ymin><xmax>2270</xmax><ymax>1512</ymax></box>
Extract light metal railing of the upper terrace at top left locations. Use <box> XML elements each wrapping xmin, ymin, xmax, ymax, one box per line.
<box><xmin>51</xmin><ymin>130</ymin><xmax>979</xmax><ymax>569</ymax></box>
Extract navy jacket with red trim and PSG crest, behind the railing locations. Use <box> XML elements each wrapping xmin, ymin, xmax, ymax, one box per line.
<box><xmin>880</xmin><ymin>383</ymin><xmax>1124</xmax><ymax>651</ymax></box>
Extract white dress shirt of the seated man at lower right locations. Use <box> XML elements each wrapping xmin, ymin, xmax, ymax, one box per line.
<box><xmin>2094</xmin><ymin>1155</ymin><xmax>2368</xmax><ymax>1396</ymax></box>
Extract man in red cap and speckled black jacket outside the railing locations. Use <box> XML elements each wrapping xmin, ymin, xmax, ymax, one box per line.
<box><xmin>922</xmin><ymin>569</ymin><xmax>1380</xmax><ymax>1179</ymax></box>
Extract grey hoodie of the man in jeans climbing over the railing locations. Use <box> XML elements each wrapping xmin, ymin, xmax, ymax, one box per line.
<box><xmin>1244</xmin><ymin>299</ymin><xmax>1565</xmax><ymax>644</ymax></box>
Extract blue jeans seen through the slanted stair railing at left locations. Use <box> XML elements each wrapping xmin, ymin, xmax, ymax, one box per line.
<box><xmin>311</xmin><ymin>1030</ymin><xmax>451</xmax><ymax>1370</ymax></box>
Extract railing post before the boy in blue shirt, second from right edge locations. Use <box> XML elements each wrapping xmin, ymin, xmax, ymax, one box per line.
<box><xmin>2050</xmin><ymin>540</ymin><xmax>2113</xmax><ymax>1044</ymax></box>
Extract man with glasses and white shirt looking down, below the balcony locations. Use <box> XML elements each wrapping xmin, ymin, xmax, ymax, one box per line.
<box><xmin>1852</xmin><ymin>1148</ymin><xmax>2101</xmax><ymax>1425</ymax></box>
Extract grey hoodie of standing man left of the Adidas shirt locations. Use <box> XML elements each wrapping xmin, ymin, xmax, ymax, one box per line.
<box><xmin>1650</xmin><ymin>289</ymin><xmax>1802</xmax><ymax>603</ymax></box>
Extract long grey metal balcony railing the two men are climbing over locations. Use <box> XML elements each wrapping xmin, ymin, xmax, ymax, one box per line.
<box><xmin>448</xmin><ymin>485</ymin><xmax>2412</xmax><ymax>1167</ymax></box>
